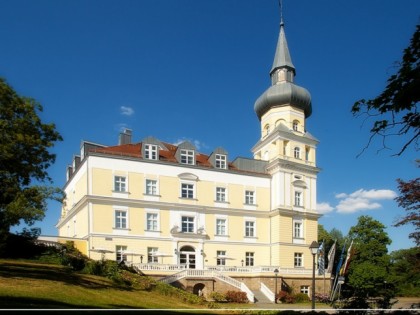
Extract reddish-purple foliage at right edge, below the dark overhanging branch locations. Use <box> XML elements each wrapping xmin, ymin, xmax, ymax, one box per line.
<box><xmin>394</xmin><ymin>177</ymin><xmax>420</xmax><ymax>246</ymax></box>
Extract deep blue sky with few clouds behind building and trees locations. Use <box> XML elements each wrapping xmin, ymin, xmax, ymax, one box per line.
<box><xmin>0</xmin><ymin>0</ymin><xmax>420</xmax><ymax>250</ymax></box>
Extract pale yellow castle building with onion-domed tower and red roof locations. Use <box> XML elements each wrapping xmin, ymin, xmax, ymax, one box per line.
<box><xmin>57</xmin><ymin>18</ymin><xmax>325</xmax><ymax>302</ymax></box>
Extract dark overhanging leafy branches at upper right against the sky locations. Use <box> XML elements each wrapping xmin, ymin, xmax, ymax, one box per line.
<box><xmin>351</xmin><ymin>25</ymin><xmax>420</xmax><ymax>155</ymax></box>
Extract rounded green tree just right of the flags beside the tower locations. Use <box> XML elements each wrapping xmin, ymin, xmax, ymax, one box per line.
<box><xmin>347</xmin><ymin>216</ymin><xmax>393</xmax><ymax>308</ymax></box>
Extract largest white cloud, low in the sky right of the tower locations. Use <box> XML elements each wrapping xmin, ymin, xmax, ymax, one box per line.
<box><xmin>335</xmin><ymin>189</ymin><xmax>397</xmax><ymax>213</ymax></box>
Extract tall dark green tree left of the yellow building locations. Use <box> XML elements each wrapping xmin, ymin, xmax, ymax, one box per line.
<box><xmin>0</xmin><ymin>78</ymin><xmax>62</xmax><ymax>241</ymax></box>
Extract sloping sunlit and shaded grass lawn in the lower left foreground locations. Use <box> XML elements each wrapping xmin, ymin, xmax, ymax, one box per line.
<box><xmin>0</xmin><ymin>260</ymin><xmax>210</xmax><ymax>309</ymax></box>
